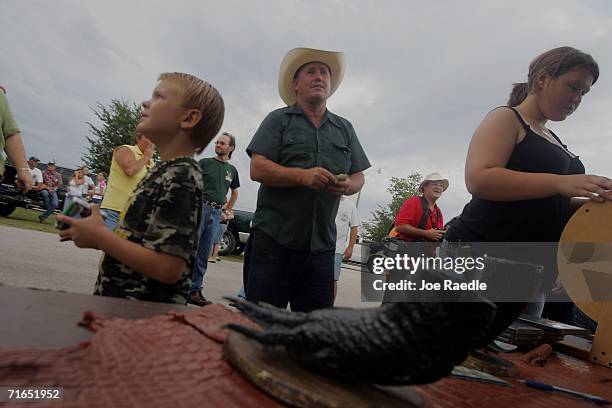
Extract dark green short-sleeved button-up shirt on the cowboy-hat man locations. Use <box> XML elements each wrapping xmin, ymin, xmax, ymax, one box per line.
<box><xmin>247</xmin><ymin>105</ymin><xmax>370</xmax><ymax>252</ymax></box>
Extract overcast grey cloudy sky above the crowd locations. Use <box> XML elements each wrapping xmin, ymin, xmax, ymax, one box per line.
<box><xmin>0</xmin><ymin>0</ymin><xmax>612</xmax><ymax>223</ymax></box>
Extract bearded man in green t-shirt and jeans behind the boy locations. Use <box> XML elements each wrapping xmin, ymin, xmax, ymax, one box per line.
<box><xmin>188</xmin><ymin>132</ymin><xmax>240</xmax><ymax>306</ymax></box>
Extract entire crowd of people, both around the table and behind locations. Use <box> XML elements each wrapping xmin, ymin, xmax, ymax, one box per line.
<box><xmin>0</xmin><ymin>47</ymin><xmax>612</xmax><ymax>328</ymax></box>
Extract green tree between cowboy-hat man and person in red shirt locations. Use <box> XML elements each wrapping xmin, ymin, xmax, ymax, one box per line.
<box><xmin>363</xmin><ymin>173</ymin><xmax>423</xmax><ymax>242</ymax></box>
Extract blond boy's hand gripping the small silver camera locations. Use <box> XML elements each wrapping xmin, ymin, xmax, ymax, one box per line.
<box><xmin>57</xmin><ymin>205</ymin><xmax>113</xmax><ymax>249</ymax></box>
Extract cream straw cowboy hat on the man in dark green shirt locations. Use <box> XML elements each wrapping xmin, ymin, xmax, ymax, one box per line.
<box><xmin>278</xmin><ymin>48</ymin><xmax>346</xmax><ymax>105</ymax></box>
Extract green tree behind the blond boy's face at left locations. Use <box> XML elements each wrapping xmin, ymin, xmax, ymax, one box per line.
<box><xmin>81</xmin><ymin>99</ymin><xmax>142</xmax><ymax>174</ymax></box>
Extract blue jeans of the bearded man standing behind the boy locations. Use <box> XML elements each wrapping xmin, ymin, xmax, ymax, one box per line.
<box><xmin>191</xmin><ymin>204</ymin><xmax>221</xmax><ymax>292</ymax></box>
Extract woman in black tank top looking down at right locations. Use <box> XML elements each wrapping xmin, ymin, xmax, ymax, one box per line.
<box><xmin>445</xmin><ymin>47</ymin><xmax>612</xmax><ymax>328</ymax></box>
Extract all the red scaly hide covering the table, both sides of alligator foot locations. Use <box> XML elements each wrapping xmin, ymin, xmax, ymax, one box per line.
<box><xmin>0</xmin><ymin>295</ymin><xmax>612</xmax><ymax>408</ymax></box>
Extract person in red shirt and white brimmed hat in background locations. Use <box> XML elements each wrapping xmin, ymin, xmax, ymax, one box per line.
<box><xmin>394</xmin><ymin>173</ymin><xmax>448</xmax><ymax>241</ymax></box>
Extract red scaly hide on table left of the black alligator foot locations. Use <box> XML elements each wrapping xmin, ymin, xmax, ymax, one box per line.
<box><xmin>0</xmin><ymin>305</ymin><xmax>279</xmax><ymax>408</ymax></box>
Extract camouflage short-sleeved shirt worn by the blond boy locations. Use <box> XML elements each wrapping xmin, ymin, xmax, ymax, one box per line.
<box><xmin>94</xmin><ymin>158</ymin><xmax>202</xmax><ymax>304</ymax></box>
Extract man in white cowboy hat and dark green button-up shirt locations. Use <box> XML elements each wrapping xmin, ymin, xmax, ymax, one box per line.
<box><xmin>244</xmin><ymin>48</ymin><xmax>370</xmax><ymax>311</ymax></box>
